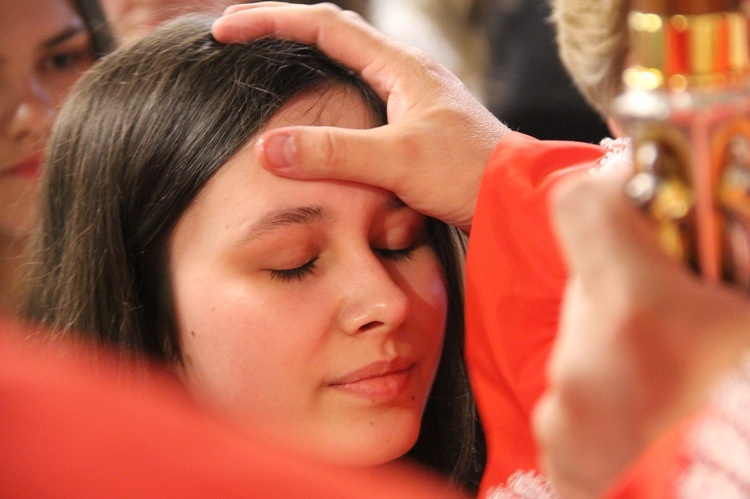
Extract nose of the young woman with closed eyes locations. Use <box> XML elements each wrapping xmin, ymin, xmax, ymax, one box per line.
<box><xmin>339</xmin><ymin>255</ymin><xmax>410</xmax><ymax>335</ymax></box>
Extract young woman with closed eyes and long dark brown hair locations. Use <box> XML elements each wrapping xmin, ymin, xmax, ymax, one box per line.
<box><xmin>26</xmin><ymin>17</ymin><xmax>482</xmax><ymax>492</ymax></box>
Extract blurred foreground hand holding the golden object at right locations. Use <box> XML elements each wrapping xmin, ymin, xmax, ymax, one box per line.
<box><xmin>534</xmin><ymin>171</ymin><xmax>750</xmax><ymax>492</ymax></box>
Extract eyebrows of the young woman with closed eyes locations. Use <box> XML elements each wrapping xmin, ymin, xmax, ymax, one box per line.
<box><xmin>238</xmin><ymin>196</ymin><xmax>406</xmax><ymax>245</ymax></box>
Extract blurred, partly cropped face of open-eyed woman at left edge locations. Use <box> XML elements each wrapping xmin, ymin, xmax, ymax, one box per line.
<box><xmin>0</xmin><ymin>0</ymin><xmax>94</xmax><ymax>236</ymax></box>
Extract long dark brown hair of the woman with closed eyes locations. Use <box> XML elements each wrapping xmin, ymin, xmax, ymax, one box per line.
<box><xmin>26</xmin><ymin>16</ymin><xmax>484</xmax><ymax>486</ymax></box>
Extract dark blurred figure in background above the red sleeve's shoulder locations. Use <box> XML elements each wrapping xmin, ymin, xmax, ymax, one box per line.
<box><xmin>478</xmin><ymin>0</ymin><xmax>610</xmax><ymax>143</ymax></box>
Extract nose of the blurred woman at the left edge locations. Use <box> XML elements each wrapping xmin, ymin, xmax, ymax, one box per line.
<box><xmin>4</xmin><ymin>77</ymin><xmax>57</xmax><ymax>147</ymax></box>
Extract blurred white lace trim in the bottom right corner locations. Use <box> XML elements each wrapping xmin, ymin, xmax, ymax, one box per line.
<box><xmin>677</xmin><ymin>356</ymin><xmax>750</xmax><ymax>499</ymax></box>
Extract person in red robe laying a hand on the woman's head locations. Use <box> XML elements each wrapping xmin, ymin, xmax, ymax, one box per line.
<box><xmin>209</xmin><ymin>4</ymin><xmax>750</xmax><ymax>498</ymax></box>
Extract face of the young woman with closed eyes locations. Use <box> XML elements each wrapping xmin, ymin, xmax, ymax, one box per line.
<box><xmin>170</xmin><ymin>90</ymin><xmax>447</xmax><ymax>466</ymax></box>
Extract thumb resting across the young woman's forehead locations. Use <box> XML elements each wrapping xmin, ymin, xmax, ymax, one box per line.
<box><xmin>255</xmin><ymin>126</ymin><xmax>404</xmax><ymax>191</ymax></box>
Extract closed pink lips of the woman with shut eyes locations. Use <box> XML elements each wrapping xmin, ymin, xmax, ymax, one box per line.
<box><xmin>328</xmin><ymin>358</ymin><xmax>415</xmax><ymax>403</ymax></box>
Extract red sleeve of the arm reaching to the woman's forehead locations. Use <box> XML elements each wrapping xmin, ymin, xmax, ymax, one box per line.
<box><xmin>466</xmin><ymin>132</ymin><xmax>604</xmax><ymax>496</ymax></box>
